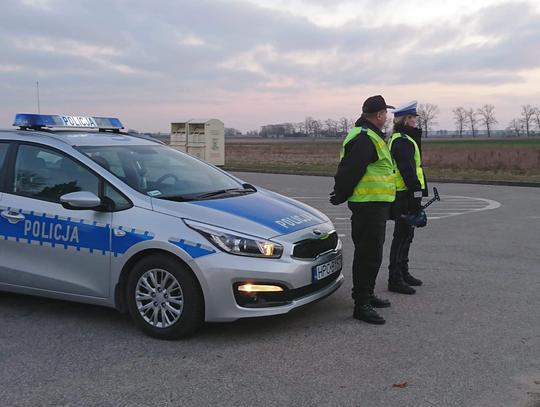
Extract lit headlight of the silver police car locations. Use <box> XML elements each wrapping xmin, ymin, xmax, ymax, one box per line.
<box><xmin>184</xmin><ymin>219</ymin><xmax>283</xmax><ymax>259</ymax></box>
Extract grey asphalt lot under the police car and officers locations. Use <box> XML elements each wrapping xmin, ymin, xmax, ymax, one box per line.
<box><xmin>0</xmin><ymin>173</ymin><xmax>540</xmax><ymax>407</ymax></box>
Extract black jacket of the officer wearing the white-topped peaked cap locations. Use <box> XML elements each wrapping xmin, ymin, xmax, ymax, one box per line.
<box><xmin>390</xmin><ymin>125</ymin><xmax>422</xmax><ymax>197</ymax></box>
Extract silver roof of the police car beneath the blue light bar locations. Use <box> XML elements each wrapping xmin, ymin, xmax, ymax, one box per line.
<box><xmin>0</xmin><ymin>129</ymin><xmax>163</xmax><ymax>146</ymax></box>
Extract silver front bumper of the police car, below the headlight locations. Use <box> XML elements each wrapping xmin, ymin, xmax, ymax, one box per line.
<box><xmin>190</xmin><ymin>226</ymin><xmax>344</xmax><ymax>322</ymax></box>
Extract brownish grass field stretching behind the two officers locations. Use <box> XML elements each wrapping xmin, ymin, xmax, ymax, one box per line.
<box><xmin>225</xmin><ymin>138</ymin><xmax>540</xmax><ymax>182</ymax></box>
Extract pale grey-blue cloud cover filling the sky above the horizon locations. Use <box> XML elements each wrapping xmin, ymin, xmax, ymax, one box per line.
<box><xmin>0</xmin><ymin>0</ymin><xmax>540</xmax><ymax>131</ymax></box>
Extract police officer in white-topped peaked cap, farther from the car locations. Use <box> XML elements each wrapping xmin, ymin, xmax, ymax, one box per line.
<box><xmin>388</xmin><ymin>101</ymin><xmax>427</xmax><ymax>294</ymax></box>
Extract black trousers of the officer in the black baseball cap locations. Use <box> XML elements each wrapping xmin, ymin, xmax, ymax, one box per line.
<box><xmin>349</xmin><ymin>202</ymin><xmax>390</xmax><ymax>305</ymax></box>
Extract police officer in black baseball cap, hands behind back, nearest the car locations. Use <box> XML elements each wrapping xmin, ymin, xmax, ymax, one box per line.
<box><xmin>330</xmin><ymin>95</ymin><xmax>396</xmax><ymax>324</ymax></box>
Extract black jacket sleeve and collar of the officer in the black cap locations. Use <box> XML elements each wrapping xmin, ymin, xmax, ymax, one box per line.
<box><xmin>334</xmin><ymin>117</ymin><xmax>384</xmax><ymax>203</ymax></box>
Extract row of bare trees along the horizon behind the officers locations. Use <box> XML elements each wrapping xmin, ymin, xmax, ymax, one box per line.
<box><xmin>225</xmin><ymin>103</ymin><xmax>540</xmax><ymax>138</ymax></box>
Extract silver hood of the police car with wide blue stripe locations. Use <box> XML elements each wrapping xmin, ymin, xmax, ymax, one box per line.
<box><xmin>152</xmin><ymin>189</ymin><xmax>329</xmax><ymax>239</ymax></box>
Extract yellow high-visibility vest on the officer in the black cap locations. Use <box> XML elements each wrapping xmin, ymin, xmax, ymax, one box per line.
<box><xmin>340</xmin><ymin>127</ymin><xmax>396</xmax><ymax>202</ymax></box>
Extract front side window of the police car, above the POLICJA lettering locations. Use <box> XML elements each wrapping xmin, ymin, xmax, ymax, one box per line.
<box><xmin>12</xmin><ymin>144</ymin><xmax>99</xmax><ymax>203</ymax></box>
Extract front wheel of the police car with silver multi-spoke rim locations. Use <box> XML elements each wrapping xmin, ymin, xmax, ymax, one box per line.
<box><xmin>126</xmin><ymin>254</ymin><xmax>204</xmax><ymax>340</ymax></box>
